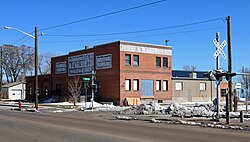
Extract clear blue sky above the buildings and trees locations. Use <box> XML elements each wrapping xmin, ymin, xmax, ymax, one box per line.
<box><xmin>0</xmin><ymin>0</ymin><xmax>250</xmax><ymax>71</ymax></box>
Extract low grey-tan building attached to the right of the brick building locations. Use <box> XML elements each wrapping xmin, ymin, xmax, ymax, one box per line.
<box><xmin>172</xmin><ymin>70</ymin><xmax>221</xmax><ymax>103</ymax></box>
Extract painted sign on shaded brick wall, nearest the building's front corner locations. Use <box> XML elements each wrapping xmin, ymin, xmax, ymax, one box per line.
<box><xmin>96</xmin><ymin>54</ymin><xmax>112</xmax><ymax>70</ymax></box>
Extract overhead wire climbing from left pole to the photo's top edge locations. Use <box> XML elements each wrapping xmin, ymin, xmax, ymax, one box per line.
<box><xmin>40</xmin><ymin>0</ymin><xmax>167</xmax><ymax>31</ymax></box>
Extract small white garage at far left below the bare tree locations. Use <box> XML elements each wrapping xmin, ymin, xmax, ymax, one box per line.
<box><xmin>2</xmin><ymin>82</ymin><xmax>25</xmax><ymax>100</ymax></box>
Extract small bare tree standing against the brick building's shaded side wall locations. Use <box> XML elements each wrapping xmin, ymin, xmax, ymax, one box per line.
<box><xmin>68</xmin><ymin>77</ymin><xmax>82</xmax><ymax>106</ymax></box>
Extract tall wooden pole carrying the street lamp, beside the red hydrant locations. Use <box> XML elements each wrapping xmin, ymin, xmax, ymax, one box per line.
<box><xmin>35</xmin><ymin>27</ymin><xmax>39</xmax><ymax>110</ymax></box>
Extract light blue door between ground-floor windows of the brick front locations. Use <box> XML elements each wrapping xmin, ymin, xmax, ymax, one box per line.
<box><xmin>141</xmin><ymin>80</ymin><xmax>154</xmax><ymax>97</ymax></box>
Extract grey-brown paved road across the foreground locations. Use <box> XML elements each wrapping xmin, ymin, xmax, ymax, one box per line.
<box><xmin>0</xmin><ymin>110</ymin><xmax>250</xmax><ymax>142</ymax></box>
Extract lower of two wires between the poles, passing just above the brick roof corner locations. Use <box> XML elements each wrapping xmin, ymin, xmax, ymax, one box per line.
<box><xmin>39</xmin><ymin>27</ymin><xmax>225</xmax><ymax>43</ymax></box>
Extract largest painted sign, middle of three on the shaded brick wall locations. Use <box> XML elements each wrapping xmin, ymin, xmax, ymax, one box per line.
<box><xmin>68</xmin><ymin>53</ymin><xmax>94</xmax><ymax>76</ymax></box>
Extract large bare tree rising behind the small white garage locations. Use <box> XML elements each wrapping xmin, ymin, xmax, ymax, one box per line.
<box><xmin>2</xmin><ymin>45</ymin><xmax>34</xmax><ymax>83</ymax></box>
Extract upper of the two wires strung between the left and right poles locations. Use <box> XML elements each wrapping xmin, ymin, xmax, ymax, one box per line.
<box><xmin>44</xmin><ymin>18</ymin><xmax>226</xmax><ymax>37</ymax></box>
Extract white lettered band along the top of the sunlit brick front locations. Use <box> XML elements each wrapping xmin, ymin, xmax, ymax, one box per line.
<box><xmin>120</xmin><ymin>44</ymin><xmax>172</xmax><ymax>56</ymax></box>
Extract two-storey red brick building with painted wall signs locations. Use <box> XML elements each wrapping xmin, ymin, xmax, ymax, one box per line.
<box><xmin>26</xmin><ymin>41</ymin><xmax>172</xmax><ymax>104</ymax></box>
